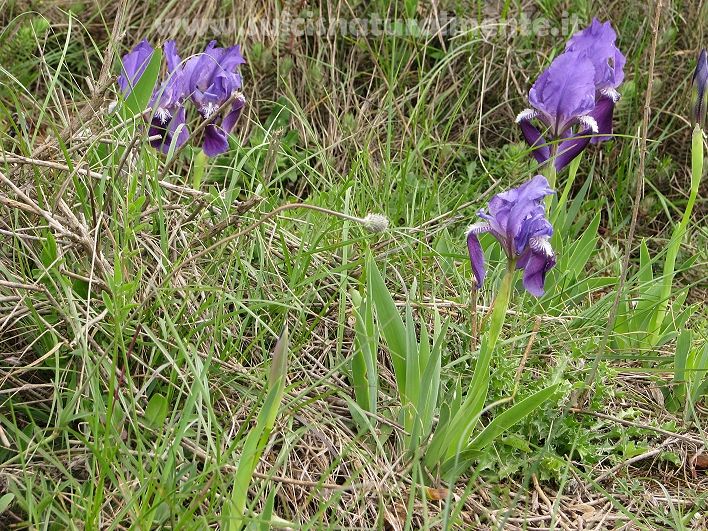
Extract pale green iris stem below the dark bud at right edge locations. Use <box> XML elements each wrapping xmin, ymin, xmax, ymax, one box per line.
<box><xmin>649</xmin><ymin>124</ymin><xmax>703</xmax><ymax>345</ymax></box>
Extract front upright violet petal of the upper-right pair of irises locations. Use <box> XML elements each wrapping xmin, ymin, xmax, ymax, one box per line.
<box><xmin>529</xmin><ymin>52</ymin><xmax>595</xmax><ymax>137</ymax></box>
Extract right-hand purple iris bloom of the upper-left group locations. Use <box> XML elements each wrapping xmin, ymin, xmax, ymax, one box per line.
<box><xmin>184</xmin><ymin>41</ymin><xmax>246</xmax><ymax>157</ymax></box>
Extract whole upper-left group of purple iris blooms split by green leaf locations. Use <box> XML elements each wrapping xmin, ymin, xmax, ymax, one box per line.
<box><xmin>118</xmin><ymin>40</ymin><xmax>246</xmax><ymax>157</ymax></box>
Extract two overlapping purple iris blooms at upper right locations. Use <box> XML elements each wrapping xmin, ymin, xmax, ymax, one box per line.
<box><xmin>516</xmin><ymin>19</ymin><xmax>625</xmax><ymax>170</ymax></box>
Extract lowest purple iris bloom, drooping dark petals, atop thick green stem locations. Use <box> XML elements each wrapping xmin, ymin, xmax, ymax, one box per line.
<box><xmin>467</xmin><ymin>175</ymin><xmax>556</xmax><ymax>297</ymax></box>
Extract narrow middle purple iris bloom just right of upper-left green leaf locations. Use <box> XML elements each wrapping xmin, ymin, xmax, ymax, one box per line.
<box><xmin>149</xmin><ymin>41</ymin><xmax>189</xmax><ymax>153</ymax></box>
